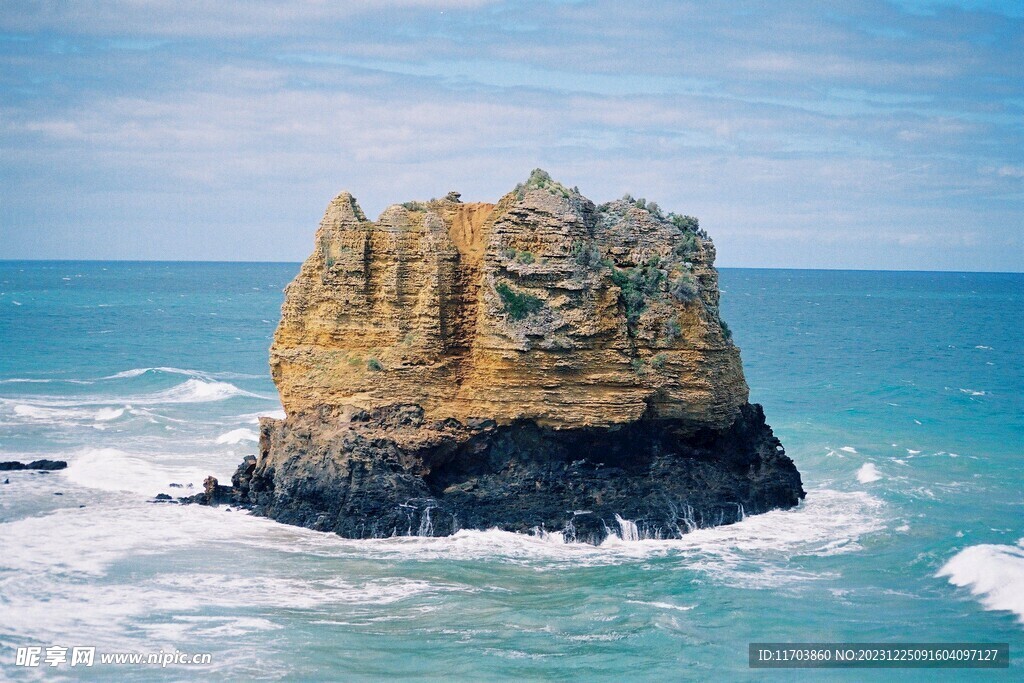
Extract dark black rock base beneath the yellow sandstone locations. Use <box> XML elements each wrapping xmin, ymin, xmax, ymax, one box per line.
<box><xmin>203</xmin><ymin>404</ymin><xmax>804</xmax><ymax>543</ymax></box>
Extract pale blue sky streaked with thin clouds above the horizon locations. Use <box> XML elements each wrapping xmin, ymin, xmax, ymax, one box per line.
<box><xmin>0</xmin><ymin>0</ymin><xmax>1024</xmax><ymax>271</ymax></box>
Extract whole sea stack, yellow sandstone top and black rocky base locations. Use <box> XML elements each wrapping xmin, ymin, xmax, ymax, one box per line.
<box><xmin>232</xmin><ymin>170</ymin><xmax>804</xmax><ymax>543</ymax></box>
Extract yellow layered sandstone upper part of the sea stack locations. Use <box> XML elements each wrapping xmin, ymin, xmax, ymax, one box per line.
<box><xmin>270</xmin><ymin>171</ymin><xmax>748</xmax><ymax>429</ymax></box>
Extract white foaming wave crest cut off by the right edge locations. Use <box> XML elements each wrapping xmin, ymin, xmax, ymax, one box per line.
<box><xmin>936</xmin><ymin>539</ymin><xmax>1024</xmax><ymax>624</ymax></box>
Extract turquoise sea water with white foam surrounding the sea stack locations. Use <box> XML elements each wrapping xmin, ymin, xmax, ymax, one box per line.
<box><xmin>0</xmin><ymin>262</ymin><xmax>1024</xmax><ymax>681</ymax></box>
